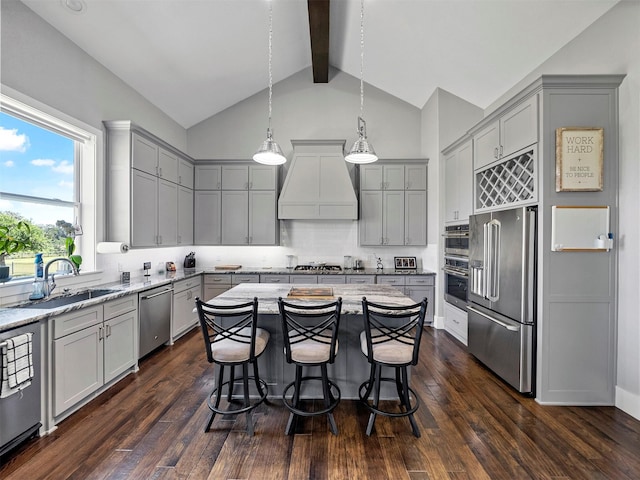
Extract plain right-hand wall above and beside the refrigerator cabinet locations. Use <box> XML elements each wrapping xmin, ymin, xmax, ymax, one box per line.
<box><xmin>487</xmin><ymin>1</ymin><xmax>640</xmax><ymax>418</ymax></box>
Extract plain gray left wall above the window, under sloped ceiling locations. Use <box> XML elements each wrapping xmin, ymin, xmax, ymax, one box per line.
<box><xmin>0</xmin><ymin>0</ymin><xmax>186</xmax><ymax>150</ymax></box>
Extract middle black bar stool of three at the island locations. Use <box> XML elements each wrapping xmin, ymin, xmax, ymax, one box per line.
<box><xmin>278</xmin><ymin>297</ymin><xmax>342</xmax><ymax>435</ymax></box>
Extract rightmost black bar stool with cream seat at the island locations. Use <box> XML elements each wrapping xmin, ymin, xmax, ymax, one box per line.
<box><xmin>358</xmin><ymin>297</ymin><xmax>427</xmax><ymax>437</ymax></box>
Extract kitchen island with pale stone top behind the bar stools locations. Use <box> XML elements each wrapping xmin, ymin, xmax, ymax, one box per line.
<box><xmin>205</xmin><ymin>283</ymin><xmax>424</xmax><ymax>399</ymax></box>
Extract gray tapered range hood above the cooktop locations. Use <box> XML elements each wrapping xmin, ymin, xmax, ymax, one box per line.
<box><xmin>278</xmin><ymin>140</ymin><xmax>358</xmax><ymax>220</ymax></box>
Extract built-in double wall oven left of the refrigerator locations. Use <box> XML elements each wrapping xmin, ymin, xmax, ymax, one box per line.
<box><xmin>442</xmin><ymin>225</ymin><xmax>469</xmax><ymax>311</ymax></box>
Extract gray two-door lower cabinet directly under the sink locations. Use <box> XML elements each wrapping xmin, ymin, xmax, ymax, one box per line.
<box><xmin>50</xmin><ymin>295</ymin><xmax>138</xmax><ymax>418</ymax></box>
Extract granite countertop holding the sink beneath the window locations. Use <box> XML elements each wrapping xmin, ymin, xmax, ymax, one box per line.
<box><xmin>0</xmin><ymin>269</ymin><xmax>202</xmax><ymax>332</ymax></box>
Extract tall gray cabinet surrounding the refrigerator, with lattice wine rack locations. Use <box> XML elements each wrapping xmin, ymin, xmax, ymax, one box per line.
<box><xmin>460</xmin><ymin>75</ymin><xmax>624</xmax><ymax>405</ymax></box>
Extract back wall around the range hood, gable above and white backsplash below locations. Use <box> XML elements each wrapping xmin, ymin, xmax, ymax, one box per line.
<box><xmin>187</xmin><ymin>68</ymin><xmax>438</xmax><ymax>270</ymax></box>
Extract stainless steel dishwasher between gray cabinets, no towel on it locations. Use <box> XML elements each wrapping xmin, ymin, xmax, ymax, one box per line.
<box><xmin>138</xmin><ymin>285</ymin><xmax>173</xmax><ymax>358</ymax></box>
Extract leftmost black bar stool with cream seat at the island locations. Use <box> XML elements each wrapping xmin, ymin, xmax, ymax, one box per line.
<box><xmin>196</xmin><ymin>297</ymin><xmax>269</xmax><ymax>435</ymax></box>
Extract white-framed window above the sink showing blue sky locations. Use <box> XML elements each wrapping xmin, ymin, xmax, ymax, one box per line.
<box><xmin>0</xmin><ymin>89</ymin><xmax>97</xmax><ymax>279</ymax></box>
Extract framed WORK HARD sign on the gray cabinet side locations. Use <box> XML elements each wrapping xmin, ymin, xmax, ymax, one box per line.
<box><xmin>556</xmin><ymin>127</ymin><xmax>604</xmax><ymax>192</ymax></box>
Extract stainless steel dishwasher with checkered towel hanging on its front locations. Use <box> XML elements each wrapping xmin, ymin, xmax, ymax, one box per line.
<box><xmin>0</xmin><ymin>322</ymin><xmax>41</xmax><ymax>456</ymax></box>
